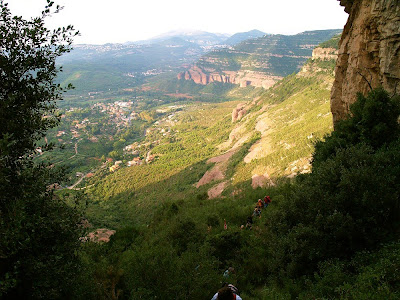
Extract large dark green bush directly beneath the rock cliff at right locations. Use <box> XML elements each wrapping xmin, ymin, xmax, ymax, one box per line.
<box><xmin>267</xmin><ymin>89</ymin><xmax>400</xmax><ymax>278</ymax></box>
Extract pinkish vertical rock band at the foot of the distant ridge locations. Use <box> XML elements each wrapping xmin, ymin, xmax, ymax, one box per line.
<box><xmin>177</xmin><ymin>66</ymin><xmax>282</xmax><ymax>89</ymax></box>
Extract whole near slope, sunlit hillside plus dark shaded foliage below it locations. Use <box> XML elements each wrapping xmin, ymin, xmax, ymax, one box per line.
<box><xmin>69</xmin><ymin>31</ymin><xmax>400</xmax><ymax>300</ymax></box>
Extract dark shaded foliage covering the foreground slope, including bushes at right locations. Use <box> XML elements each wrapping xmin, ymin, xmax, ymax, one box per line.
<box><xmin>75</xmin><ymin>90</ymin><xmax>400</xmax><ymax>299</ymax></box>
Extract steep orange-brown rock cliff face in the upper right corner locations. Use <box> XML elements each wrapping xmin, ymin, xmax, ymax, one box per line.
<box><xmin>331</xmin><ymin>0</ymin><xmax>400</xmax><ymax>123</ymax></box>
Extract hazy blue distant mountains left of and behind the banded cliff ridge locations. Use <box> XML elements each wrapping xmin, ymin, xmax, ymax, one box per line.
<box><xmin>58</xmin><ymin>30</ymin><xmax>268</xmax><ymax>93</ymax></box>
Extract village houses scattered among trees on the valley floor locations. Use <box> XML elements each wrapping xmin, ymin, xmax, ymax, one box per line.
<box><xmin>47</xmin><ymin>101</ymin><xmax>183</xmax><ymax>175</ymax></box>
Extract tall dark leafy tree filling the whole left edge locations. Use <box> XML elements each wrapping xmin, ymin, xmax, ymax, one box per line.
<box><xmin>0</xmin><ymin>0</ymin><xmax>81</xmax><ymax>299</ymax></box>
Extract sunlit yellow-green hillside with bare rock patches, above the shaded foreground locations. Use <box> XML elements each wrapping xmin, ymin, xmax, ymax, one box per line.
<box><xmin>83</xmin><ymin>43</ymin><xmax>340</xmax><ymax>226</ymax></box>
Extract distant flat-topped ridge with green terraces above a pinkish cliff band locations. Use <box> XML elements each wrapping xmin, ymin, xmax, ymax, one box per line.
<box><xmin>178</xmin><ymin>30</ymin><xmax>341</xmax><ymax>88</ymax></box>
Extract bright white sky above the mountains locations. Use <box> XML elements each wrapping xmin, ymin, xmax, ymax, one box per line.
<box><xmin>5</xmin><ymin>0</ymin><xmax>348</xmax><ymax>44</ymax></box>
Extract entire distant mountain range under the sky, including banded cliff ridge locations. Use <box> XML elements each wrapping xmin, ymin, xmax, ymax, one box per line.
<box><xmin>58</xmin><ymin>30</ymin><xmax>341</xmax><ymax>92</ymax></box>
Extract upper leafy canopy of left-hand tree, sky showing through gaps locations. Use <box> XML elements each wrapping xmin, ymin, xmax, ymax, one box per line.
<box><xmin>0</xmin><ymin>0</ymin><xmax>78</xmax><ymax>160</ymax></box>
